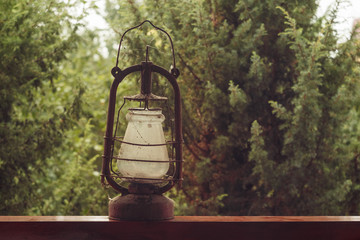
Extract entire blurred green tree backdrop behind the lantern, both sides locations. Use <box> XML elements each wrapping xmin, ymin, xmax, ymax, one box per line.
<box><xmin>0</xmin><ymin>0</ymin><xmax>360</xmax><ymax>215</ymax></box>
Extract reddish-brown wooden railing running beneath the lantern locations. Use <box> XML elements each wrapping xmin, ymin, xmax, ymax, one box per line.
<box><xmin>0</xmin><ymin>216</ymin><xmax>360</xmax><ymax>240</ymax></box>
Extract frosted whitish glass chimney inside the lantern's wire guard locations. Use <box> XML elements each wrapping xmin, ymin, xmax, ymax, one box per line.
<box><xmin>117</xmin><ymin>109</ymin><xmax>169</xmax><ymax>182</ymax></box>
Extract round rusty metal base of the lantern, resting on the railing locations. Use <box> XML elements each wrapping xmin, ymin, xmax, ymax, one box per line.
<box><xmin>109</xmin><ymin>194</ymin><xmax>174</xmax><ymax>221</ymax></box>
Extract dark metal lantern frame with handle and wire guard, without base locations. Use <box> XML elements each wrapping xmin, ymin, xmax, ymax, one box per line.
<box><xmin>101</xmin><ymin>20</ymin><xmax>183</xmax><ymax>195</ymax></box>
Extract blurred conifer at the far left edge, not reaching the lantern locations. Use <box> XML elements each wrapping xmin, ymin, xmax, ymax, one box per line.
<box><xmin>0</xmin><ymin>0</ymin><xmax>83</xmax><ymax>215</ymax></box>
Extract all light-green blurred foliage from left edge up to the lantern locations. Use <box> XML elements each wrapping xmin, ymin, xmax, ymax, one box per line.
<box><xmin>0</xmin><ymin>0</ymin><xmax>107</xmax><ymax>215</ymax></box>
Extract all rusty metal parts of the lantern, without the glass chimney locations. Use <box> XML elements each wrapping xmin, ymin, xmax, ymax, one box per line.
<box><xmin>101</xmin><ymin>20</ymin><xmax>183</xmax><ymax>221</ymax></box>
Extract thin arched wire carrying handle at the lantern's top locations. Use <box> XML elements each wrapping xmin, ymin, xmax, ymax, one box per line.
<box><xmin>111</xmin><ymin>20</ymin><xmax>180</xmax><ymax>78</ymax></box>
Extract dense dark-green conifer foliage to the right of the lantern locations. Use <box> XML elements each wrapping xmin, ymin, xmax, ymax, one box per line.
<box><xmin>107</xmin><ymin>0</ymin><xmax>359</xmax><ymax>215</ymax></box>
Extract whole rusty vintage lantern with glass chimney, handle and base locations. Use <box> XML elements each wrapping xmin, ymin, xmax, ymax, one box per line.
<box><xmin>101</xmin><ymin>20</ymin><xmax>183</xmax><ymax>220</ymax></box>
